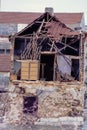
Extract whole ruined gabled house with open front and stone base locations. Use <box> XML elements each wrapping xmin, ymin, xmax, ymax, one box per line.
<box><xmin>2</xmin><ymin>8</ymin><xmax>86</xmax><ymax>124</ymax></box>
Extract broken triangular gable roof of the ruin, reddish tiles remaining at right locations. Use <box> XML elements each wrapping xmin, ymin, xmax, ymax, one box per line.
<box><xmin>17</xmin><ymin>12</ymin><xmax>78</xmax><ymax>35</ymax></box>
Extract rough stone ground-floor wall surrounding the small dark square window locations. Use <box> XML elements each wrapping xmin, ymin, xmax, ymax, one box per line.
<box><xmin>0</xmin><ymin>81</ymin><xmax>83</xmax><ymax>125</ymax></box>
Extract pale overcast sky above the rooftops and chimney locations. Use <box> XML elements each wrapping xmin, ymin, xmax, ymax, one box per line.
<box><xmin>1</xmin><ymin>0</ymin><xmax>87</xmax><ymax>24</ymax></box>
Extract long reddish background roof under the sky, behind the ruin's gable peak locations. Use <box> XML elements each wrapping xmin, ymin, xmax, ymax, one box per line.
<box><xmin>0</xmin><ymin>12</ymin><xmax>83</xmax><ymax>24</ymax></box>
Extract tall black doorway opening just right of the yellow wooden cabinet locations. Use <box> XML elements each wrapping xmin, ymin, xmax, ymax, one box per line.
<box><xmin>40</xmin><ymin>54</ymin><xmax>55</xmax><ymax>81</ymax></box>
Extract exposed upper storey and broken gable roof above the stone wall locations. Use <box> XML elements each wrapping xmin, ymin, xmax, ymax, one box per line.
<box><xmin>13</xmin><ymin>13</ymin><xmax>85</xmax><ymax>81</ymax></box>
